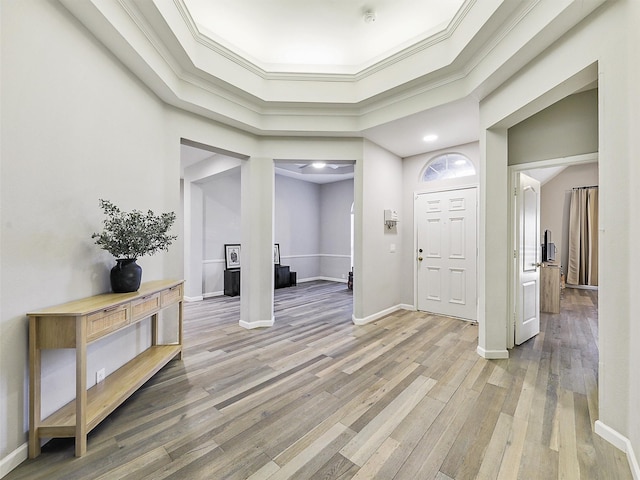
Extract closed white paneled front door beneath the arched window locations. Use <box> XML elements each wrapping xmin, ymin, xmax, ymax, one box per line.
<box><xmin>415</xmin><ymin>188</ymin><xmax>477</xmax><ymax>321</ymax></box>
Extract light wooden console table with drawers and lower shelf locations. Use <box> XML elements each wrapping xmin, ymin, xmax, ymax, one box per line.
<box><xmin>27</xmin><ymin>280</ymin><xmax>184</xmax><ymax>458</ymax></box>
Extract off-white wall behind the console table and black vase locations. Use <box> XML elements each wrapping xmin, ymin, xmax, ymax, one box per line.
<box><xmin>0</xmin><ymin>1</ymin><xmax>182</xmax><ymax>464</ymax></box>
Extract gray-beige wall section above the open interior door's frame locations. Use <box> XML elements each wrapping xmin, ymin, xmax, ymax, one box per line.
<box><xmin>508</xmin><ymin>89</ymin><xmax>598</xmax><ymax>165</ymax></box>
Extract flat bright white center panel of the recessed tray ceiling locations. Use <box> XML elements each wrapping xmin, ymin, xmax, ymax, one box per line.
<box><xmin>183</xmin><ymin>0</ymin><xmax>464</xmax><ymax>73</ymax></box>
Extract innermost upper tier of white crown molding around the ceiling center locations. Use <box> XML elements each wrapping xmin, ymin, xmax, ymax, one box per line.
<box><xmin>131</xmin><ymin>0</ymin><xmax>520</xmax><ymax>105</ymax></box>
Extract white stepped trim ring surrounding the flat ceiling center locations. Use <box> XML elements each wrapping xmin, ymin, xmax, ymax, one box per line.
<box><xmin>60</xmin><ymin>0</ymin><xmax>606</xmax><ymax>144</ymax></box>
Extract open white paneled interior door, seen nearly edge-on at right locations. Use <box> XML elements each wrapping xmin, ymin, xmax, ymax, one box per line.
<box><xmin>515</xmin><ymin>173</ymin><xmax>541</xmax><ymax>345</ymax></box>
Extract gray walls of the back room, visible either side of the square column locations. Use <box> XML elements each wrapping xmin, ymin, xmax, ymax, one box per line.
<box><xmin>200</xmin><ymin>172</ymin><xmax>354</xmax><ymax>297</ymax></box>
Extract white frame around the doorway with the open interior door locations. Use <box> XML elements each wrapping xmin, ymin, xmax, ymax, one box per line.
<box><xmin>506</xmin><ymin>152</ymin><xmax>598</xmax><ymax>349</ymax></box>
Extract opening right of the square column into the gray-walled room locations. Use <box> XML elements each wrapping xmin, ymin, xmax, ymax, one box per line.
<box><xmin>273</xmin><ymin>159</ymin><xmax>355</xmax><ymax>321</ymax></box>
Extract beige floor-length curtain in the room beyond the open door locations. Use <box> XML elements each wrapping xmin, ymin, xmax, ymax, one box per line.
<box><xmin>567</xmin><ymin>187</ymin><xmax>598</xmax><ymax>285</ymax></box>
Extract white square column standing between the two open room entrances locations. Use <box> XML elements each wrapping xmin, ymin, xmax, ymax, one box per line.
<box><xmin>240</xmin><ymin>158</ymin><xmax>275</xmax><ymax>328</ymax></box>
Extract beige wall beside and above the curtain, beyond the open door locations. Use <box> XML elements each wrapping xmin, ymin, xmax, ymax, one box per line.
<box><xmin>540</xmin><ymin>163</ymin><xmax>598</xmax><ymax>274</ymax></box>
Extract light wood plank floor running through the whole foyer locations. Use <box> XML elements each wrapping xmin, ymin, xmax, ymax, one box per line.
<box><xmin>6</xmin><ymin>282</ymin><xmax>632</xmax><ymax>480</ymax></box>
